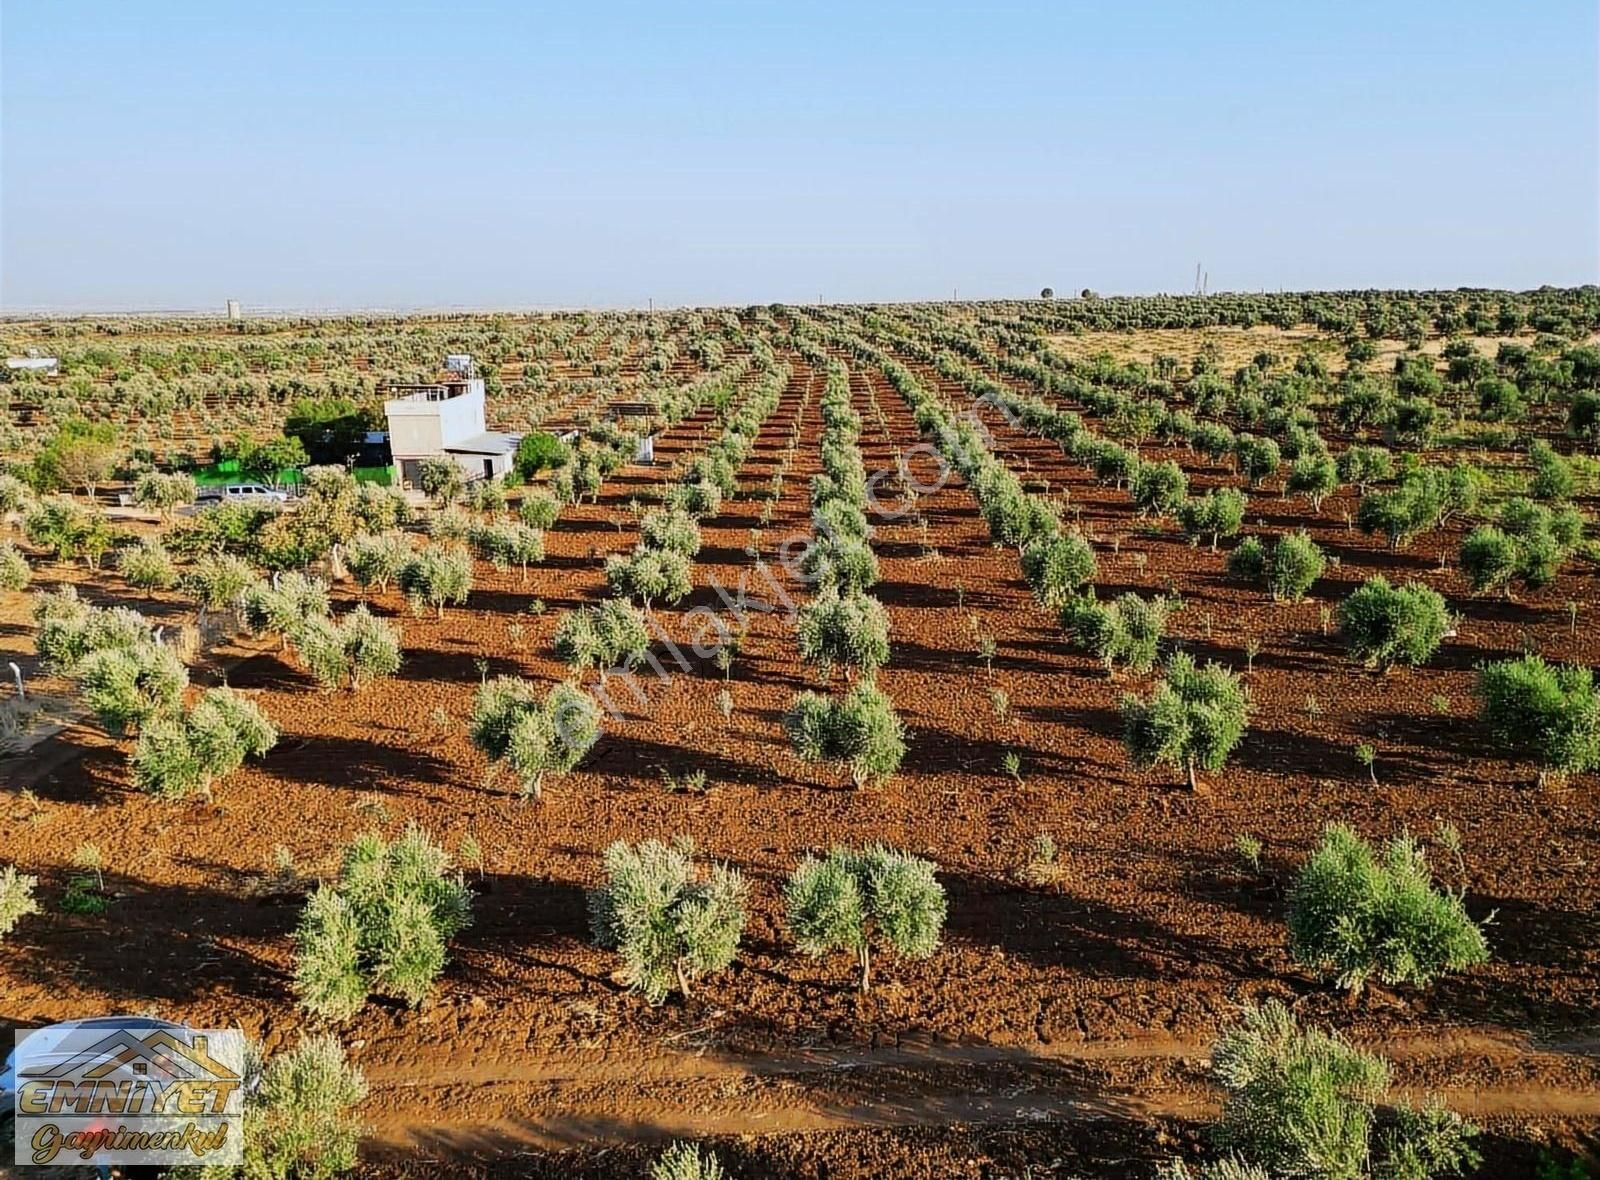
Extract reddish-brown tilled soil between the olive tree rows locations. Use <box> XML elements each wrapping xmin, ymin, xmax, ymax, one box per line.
<box><xmin>0</xmin><ymin>345</ymin><xmax>1600</xmax><ymax>1178</ymax></box>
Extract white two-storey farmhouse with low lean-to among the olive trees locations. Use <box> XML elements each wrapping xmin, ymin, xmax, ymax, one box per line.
<box><xmin>384</xmin><ymin>357</ymin><xmax>522</xmax><ymax>488</ymax></box>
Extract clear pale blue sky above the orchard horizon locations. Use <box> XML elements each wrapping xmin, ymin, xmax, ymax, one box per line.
<box><xmin>0</xmin><ymin>0</ymin><xmax>1600</xmax><ymax>312</ymax></box>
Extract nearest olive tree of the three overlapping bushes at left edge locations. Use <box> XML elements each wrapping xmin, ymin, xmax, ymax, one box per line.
<box><xmin>131</xmin><ymin>688</ymin><xmax>278</xmax><ymax>799</ymax></box>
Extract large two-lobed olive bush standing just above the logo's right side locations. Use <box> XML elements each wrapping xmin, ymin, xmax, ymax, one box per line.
<box><xmin>294</xmin><ymin>825</ymin><xmax>472</xmax><ymax>1020</ymax></box>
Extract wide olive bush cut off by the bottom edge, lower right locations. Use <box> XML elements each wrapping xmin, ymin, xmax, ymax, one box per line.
<box><xmin>1202</xmin><ymin>999</ymin><xmax>1478</xmax><ymax>1180</ymax></box>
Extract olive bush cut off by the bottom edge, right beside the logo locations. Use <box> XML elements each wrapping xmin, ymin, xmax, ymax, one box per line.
<box><xmin>236</xmin><ymin>1034</ymin><xmax>366</xmax><ymax>1180</ymax></box>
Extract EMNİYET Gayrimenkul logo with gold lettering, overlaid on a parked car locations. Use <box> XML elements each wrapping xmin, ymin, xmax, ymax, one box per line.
<box><xmin>0</xmin><ymin>1017</ymin><xmax>245</xmax><ymax>1167</ymax></box>
